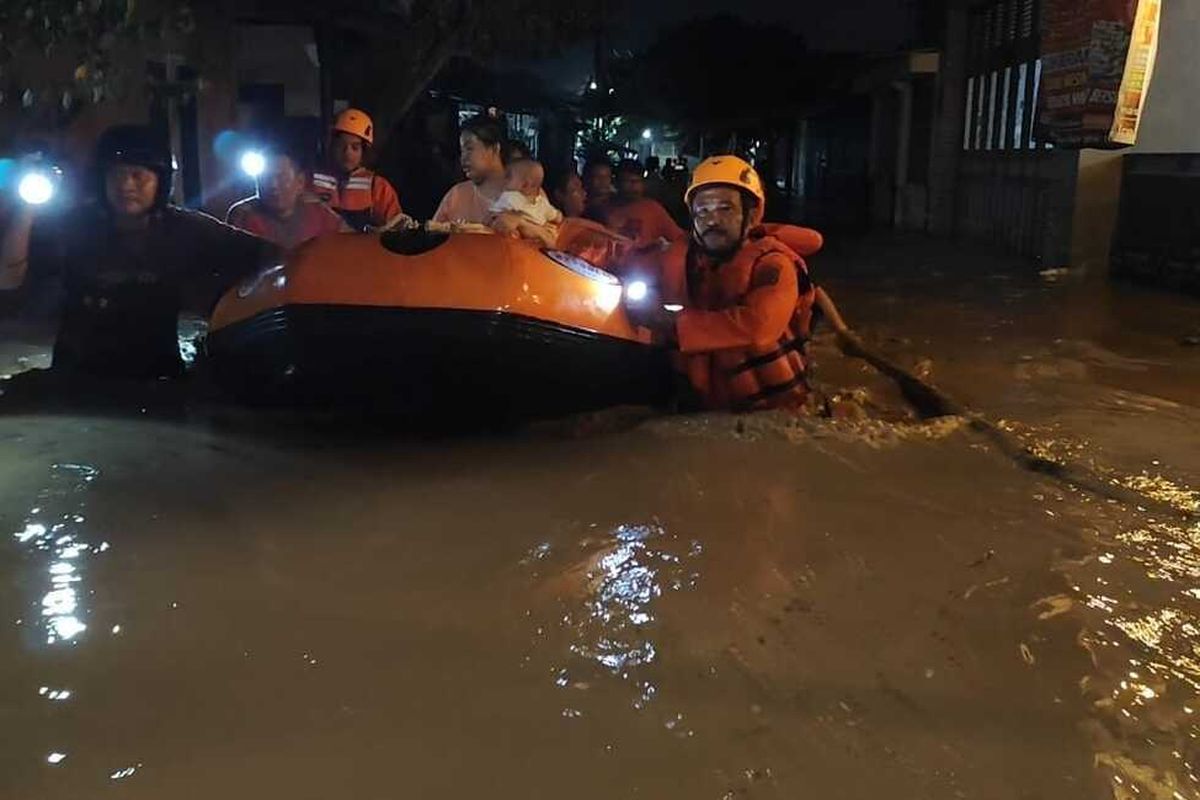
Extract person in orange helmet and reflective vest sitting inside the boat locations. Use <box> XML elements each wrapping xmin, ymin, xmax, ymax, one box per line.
<box><xmin>312</xmin><ymin>108</ymin><xmax>403</xmax><ymax>230</ymax></box>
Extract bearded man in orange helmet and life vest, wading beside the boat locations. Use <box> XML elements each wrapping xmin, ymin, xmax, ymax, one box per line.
<box><xmin>631</xmin><ymin>156</ymin><xmax>814</xmax><ymax>411</ymax></box>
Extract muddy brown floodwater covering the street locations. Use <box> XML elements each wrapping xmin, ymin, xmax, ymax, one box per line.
<box><xmin>0</xmin><ymin>235</ymin><xmax>1200</xmax><ymax>800</ymax></box>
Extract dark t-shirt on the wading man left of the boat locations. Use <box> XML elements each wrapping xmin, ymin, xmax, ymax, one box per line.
<box><xmin>30</xmin><ymin>206</ymin><xmax>277</xmax><ymax>378</ymax></box>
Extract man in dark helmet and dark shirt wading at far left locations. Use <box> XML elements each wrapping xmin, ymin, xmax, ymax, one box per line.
<box><xmin>0</xmin><ymin>126</ymin><xmax>276</xmax><ymax>379</ymax></box>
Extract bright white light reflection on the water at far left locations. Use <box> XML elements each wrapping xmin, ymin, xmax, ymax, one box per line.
<box><xmin>13</xmin><ymin>464</ymin><xmax>100</xmax><ymax>647</ymax></box>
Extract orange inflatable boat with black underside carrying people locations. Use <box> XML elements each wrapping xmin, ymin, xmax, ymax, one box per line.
<box><xmin>206</xmin><ymin>229</ymin><xmax>671</xmax><ymax>416</ymax></box>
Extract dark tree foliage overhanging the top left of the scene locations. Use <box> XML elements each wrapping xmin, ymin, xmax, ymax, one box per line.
<box><xmin>0</xmin><ymin>0</ymin><xmax>602</xmax><ymax>145</ymax></box>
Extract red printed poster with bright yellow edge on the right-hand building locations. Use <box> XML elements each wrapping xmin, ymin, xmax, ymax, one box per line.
<box><xmin>1038</xmin><ymin>0</ymin><xmax>1163</xmax><ymax>148</ymax></box>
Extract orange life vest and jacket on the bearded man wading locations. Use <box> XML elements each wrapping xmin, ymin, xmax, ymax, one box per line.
<box><xmin>662</xmin><ymin>236</ymin><xmax>815</xmax><ymax>411</ymax></box>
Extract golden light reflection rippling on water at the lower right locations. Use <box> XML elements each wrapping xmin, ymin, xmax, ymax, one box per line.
<box><xmin>1041</xmin><ymin>475</ymin><xmax>1200</xmax><ymax>800</ymax></box>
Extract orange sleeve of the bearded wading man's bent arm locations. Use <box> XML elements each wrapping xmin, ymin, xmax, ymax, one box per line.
<box><xmin>676</xmin><ymin>253</ymin><xmax>798</xmax><ymax>353</ymax></box>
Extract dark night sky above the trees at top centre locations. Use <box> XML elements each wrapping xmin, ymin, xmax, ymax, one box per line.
<box><xmin>530</xmin><ymin>0</ymin><xmax>913</xmax><ymax>91</ymax></box>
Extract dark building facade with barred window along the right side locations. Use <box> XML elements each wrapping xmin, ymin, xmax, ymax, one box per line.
<box><xmin>798</xmin><ymin>0</ymin><xmax>1200</xmax><ymax>283</ymax></box>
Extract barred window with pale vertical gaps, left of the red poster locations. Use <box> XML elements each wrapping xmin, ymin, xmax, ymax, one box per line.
<box><xmin>962</xmin><ymin>0</ymin><xmax>1042</xmax><ymax>151</ymax></box>
